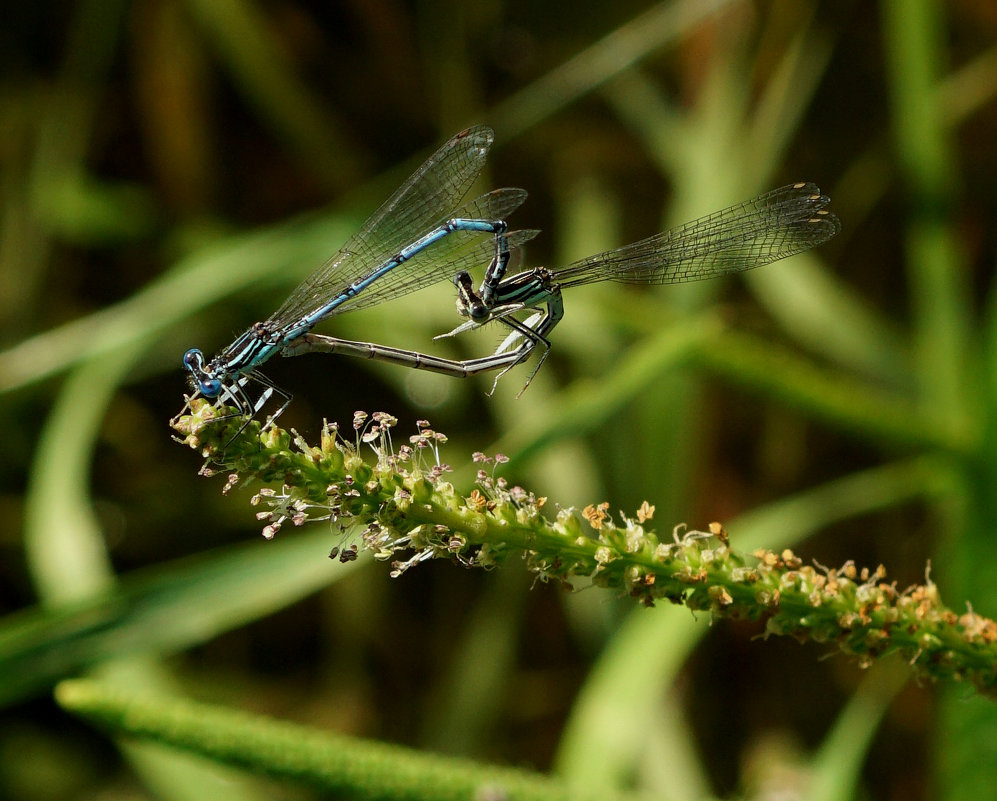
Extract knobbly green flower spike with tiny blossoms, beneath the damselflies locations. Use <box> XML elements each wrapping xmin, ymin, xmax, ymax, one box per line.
<box><xmin>173</xmin><ymin>400</ymin><xmax>997</xmax><ymax>696</ymax></box>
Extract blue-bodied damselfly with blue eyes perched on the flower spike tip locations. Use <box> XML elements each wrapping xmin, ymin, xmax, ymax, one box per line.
<box><xmin>183</xmin><ymin>126</ymin><xmax>537</xmax><ymax>420</ymax></box>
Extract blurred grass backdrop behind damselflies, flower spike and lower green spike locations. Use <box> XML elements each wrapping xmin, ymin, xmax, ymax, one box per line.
<box><xmin>0</xmin><ymin>0</ymin><xmax>997</xmax><ymax>801</ymax></box>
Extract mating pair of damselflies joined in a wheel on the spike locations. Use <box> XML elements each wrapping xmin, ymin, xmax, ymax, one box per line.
<box><xmin>183</xmin><ymin>126</ymin><xmax>841</xmax><ymax>421</ymax></box>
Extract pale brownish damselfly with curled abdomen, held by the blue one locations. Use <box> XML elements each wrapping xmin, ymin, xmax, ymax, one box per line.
<box><xmin>286</xmin><ymin>182</ymin><xmax>841</xmax><ymax>391</ymax></box>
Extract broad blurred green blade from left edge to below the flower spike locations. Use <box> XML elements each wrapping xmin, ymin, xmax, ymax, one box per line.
<box><xmin>0</xmin><ymin>526</ymin><xmax>356</xmax><ymax>704</ymax></box>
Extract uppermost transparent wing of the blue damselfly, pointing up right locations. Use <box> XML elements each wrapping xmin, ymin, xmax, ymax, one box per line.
<box><xmin>267</xmin><ymin>125</ymin><xmax>495</xmax><ymax>329</ymax></box>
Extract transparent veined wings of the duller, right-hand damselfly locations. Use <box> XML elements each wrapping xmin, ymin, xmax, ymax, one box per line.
<box><xmin>551</xmin><ymin>183</ymin><xmax>841</xmax><ymax>287</ymax></box>
